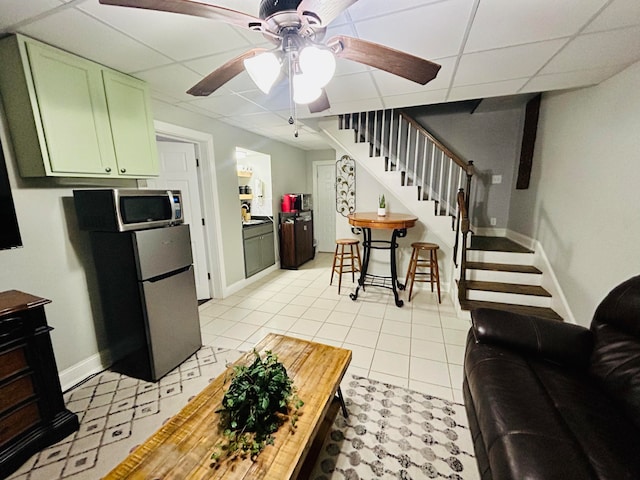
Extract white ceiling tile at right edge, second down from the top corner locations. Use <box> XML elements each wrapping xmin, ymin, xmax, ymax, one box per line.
<box><xmin>540</xmin><ymin>27</ymin><xmax>640</xmax><ymax>73</ymax></box>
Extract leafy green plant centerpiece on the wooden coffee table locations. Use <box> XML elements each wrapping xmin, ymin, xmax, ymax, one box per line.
<box><xmin>211</xmin><ymin>350</ymin><xmax>304</xmax><ymax>462</ymax></box>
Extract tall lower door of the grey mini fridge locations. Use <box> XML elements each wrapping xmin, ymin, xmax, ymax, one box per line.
<box><xmin>141</xmin><ymin>266</ymin><xmax>202</xmax><ymax>381</ymax></box>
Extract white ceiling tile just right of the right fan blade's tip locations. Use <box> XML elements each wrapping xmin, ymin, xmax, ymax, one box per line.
<box><xmin>454</xmin><ymin>40</ymin><xmax>566</xmax><ymax>86</ymax></box>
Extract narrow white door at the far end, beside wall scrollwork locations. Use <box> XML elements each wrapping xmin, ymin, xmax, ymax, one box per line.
<box><xmin>313</xmin><ymin>161</ymin><xmax>336</xmax><ymax>252</ymax></box>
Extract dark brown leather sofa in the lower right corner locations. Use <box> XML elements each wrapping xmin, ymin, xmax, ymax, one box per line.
<box><xmin>463</xmin><ymin>276</ymin><xmax>640</xmax><ymax>480</ymax></box>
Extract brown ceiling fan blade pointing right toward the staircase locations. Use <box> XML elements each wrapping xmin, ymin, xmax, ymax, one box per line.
<box><xmin>327</xmin><ymin>35</ymin><xmax>440</xmax><ymax>85</ymax></box>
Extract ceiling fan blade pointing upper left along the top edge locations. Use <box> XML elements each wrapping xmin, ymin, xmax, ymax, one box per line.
<box><xmin>99</xmin><ymin>0</ymin><xmax>263</xmax><ymax>31</ymax></box>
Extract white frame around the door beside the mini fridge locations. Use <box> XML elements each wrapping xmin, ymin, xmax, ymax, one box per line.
<box><xmin>153</xmin><ymin>120</ymin><xmax>226</xmax><ymax>298</ymax></box>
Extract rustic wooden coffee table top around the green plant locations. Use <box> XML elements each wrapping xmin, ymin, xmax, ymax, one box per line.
<box><xmin>104</xmin><ymin>333</ymin><xmax>351</xmax><ymax>480</ymax></box>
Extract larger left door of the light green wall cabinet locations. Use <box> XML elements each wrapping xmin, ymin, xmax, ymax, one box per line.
<box><xmin>26</xmin><ymin>42</ymin><xmax>116</xmax><ymax>175</ymax></box>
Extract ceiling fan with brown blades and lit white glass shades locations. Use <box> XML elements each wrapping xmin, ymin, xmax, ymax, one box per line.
<box><xmin>99</xmin><ymin>0</ymin><xmax>440</xmax><ymax>117</ymax></box>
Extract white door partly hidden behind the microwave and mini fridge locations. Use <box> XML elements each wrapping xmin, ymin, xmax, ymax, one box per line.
<box><xmin>147</xmin><ymin>142</ymin><xmax>211</xmax><ymax>300</ymax></box>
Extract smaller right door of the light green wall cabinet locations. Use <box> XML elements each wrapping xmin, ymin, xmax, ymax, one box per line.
<box><xmin>102</xmin><ymin>70</ymin><xmax>158</xmax><ymax>177</ymax></box>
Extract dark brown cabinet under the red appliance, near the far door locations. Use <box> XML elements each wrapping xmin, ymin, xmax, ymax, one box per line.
<box><xmin>279</xmin><ymin>210</ymin><xmax>315</xmax><ymax>269</ymax></box>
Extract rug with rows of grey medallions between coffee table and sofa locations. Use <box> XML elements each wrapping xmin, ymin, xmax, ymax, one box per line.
<box><xmin>311</xmin><ymin>375</ymin><xmax>479</xmax><ymax>480</ymax></box>
